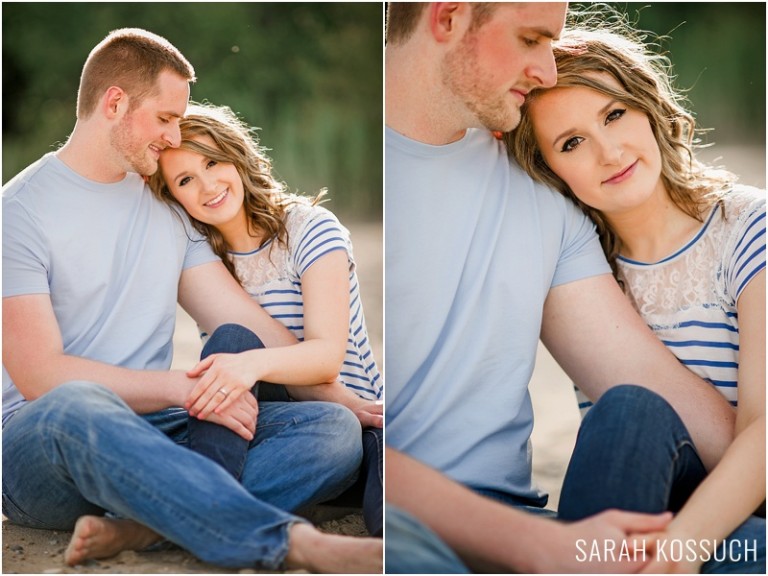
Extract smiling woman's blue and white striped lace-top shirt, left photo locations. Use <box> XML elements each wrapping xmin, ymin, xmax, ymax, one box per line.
<box><xmin>230</xmin><ymin>202</ymin><xmax>383</xmax><ymax>400</ymax></box>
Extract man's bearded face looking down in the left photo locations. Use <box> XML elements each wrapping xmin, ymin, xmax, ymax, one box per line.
<box><xmin>110</xmin><ymin>72</ymin><xmax>189</xmax><ymax>176</ymax></box>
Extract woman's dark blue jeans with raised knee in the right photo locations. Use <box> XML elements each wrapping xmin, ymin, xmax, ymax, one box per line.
<box><xmin>558</xmin><ymin>386</ymin><xmax>765</xmax><ymax>574</ymax></box>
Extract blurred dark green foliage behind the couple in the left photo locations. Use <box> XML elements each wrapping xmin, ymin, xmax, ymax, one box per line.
<box><xmin>2</xmin><ymin>2</ymin><xmax>384</xmax><ymax>220</ymax></box>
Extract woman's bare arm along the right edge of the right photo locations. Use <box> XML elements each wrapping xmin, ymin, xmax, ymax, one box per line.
<box><xmin>647</xmin><ymin>270</ymin><xmax>765</xmax><ymax>573</ymax></box>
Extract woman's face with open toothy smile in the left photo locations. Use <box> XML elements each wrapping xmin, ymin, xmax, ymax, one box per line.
<box><xmin>160</xmin><ymin>136</ymin><xmax>244</xmax><ymax>228</ymax></box>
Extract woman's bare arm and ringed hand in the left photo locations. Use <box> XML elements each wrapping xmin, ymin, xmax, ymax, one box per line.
<box><xmin>186</xmin><ymin>250</ymin><xmax>349</xmax><ymax>419</ymax></box>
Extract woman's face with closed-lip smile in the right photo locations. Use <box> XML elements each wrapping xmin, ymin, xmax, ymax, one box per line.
<box><xmin>528</xmin><ymin>74</ymin><xmax>664</xmax><ymax>216</ymax></box>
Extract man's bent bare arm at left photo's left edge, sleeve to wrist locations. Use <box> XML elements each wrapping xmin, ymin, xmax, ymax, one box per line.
<box><xmin>3</xmin><ymin>294</ymin><xmax>194</xmax><ymax>413</ymax></box>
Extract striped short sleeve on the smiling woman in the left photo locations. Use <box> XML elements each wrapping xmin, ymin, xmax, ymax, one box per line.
<box><xmin>293</xmin><ymin>207</ymin><xmax>353</xmax><ymax>277</ymax></box>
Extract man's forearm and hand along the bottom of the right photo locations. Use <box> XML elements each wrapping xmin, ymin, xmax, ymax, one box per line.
<box><xmin>385</xmin><ymin>448</ymin><xmax>671</xmax><ymax>574</ymax></box>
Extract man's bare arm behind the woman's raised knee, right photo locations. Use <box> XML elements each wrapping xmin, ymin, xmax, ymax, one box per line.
<box><xmin>541</xmin><ymin>275</ymin><xmax>735</xmax><ymax>470</ymax></box>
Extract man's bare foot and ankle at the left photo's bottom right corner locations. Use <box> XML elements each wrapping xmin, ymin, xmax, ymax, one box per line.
<box><xmin>285</xmin><ymin>524</ymin><xmax>384</xmax><ymax>574</ymax></box>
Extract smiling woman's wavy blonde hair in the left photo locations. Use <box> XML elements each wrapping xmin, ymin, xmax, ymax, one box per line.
<box><xmin>149</xmin><ymin>103</ymin><xmax>326</xmax><ymax>282</ymax></box>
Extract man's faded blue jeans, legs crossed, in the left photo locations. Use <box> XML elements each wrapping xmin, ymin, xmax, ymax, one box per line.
<box><xmin>2</xmin><ymin>338</ymin><xmax>362</xmax><ymax>569</ymax></box>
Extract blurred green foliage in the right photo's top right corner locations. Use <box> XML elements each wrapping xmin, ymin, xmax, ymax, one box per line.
<box><xmin>571</xmin><ymin>2</ymin><xmax>766</xmax><ymax>147</ymax></box>
